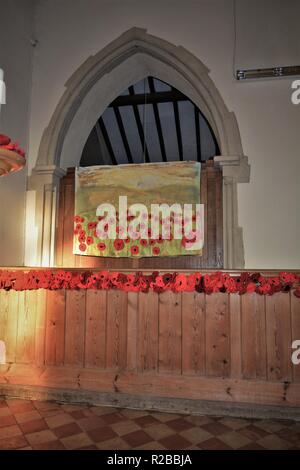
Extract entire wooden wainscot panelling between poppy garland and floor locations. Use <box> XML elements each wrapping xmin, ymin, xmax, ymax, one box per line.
<box><xmin>0</xmin><ymin>278</ymin><xmax>300</xmax><ymax>414</ymax></box>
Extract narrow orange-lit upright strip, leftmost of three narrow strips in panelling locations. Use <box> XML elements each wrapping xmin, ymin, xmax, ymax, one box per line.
<box><xmin>35</xmin><ymin>289</ymin><xmax>47</xmax><ymax>366</ymax></box>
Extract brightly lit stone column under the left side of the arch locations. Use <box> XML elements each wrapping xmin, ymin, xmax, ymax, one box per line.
<box><xmin>25</xmin><ymin>165</ymin><xmax>66</xmax><ymax>266</ymax></box>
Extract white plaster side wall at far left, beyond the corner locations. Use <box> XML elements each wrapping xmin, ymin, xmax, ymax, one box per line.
<box><xmin>0</xmin><ymin>0</ymin><xmax>34</xmax><ymax>266</ymax></box>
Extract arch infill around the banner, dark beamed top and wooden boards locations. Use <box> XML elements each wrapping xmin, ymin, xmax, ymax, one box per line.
<box><xmin>56</xmin><ymin>77</ymin><xmax>223</xmax><ymax>269</ymax></box>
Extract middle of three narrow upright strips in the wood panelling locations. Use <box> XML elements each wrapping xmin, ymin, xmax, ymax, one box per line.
<box><xmin>127</xmin><ymin>292</ymin><xmax>139</xmax><ymax>370</ymax></box>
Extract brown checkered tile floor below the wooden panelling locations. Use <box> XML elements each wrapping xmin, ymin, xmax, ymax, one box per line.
<box><xmin>0</xmin><ymin>400</ymin><xmax>300</xmax><ymax>450</ymax></box>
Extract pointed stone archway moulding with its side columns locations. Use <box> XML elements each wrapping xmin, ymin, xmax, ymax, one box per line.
<box><xmin>25</xmin><ymin>28</ymin><xmax>250</xmax><ymax>269</ymax></box>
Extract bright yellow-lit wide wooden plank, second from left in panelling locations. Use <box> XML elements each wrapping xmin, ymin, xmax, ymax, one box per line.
<box><xmin>16</xmin><ymin>291</ymin><xmax>37</xmax><ymax>364</ymax></box>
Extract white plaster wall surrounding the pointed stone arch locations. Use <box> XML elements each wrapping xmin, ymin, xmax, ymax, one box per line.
<box><xmin>11</xmin><ymin>0</ymin><xmax>300</xmax><ymax>268</ymax></box>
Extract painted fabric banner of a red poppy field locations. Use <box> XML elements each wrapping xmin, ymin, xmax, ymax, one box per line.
<box><xmin>73</xmin><ymin>162</ymin><xmax>203</xmax><ymax>257</ymax></box>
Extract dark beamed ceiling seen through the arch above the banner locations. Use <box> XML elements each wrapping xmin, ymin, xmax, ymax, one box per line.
<box><xmin>80</xmin><ymin>77</ymin><xmax>220</xmax><ymax>166</ymax></box>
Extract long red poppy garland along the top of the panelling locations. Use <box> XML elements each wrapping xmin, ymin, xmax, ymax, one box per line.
<box><xmin>0</xmin><ymin>269</ymin><xmax>300</xmax><ymax>298</ymax></box>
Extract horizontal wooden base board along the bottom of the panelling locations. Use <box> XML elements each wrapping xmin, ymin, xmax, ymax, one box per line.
<box><xmin>0</xmin><ymin>364</ymin><xmax>300</xmax><ymax>407</ymax></box>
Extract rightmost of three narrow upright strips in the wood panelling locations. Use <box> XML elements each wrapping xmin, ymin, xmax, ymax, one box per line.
<box><xmin>229</xmin><ymin>294</ymin><xmax>242</xmax><ymax>378</ymax></box>
